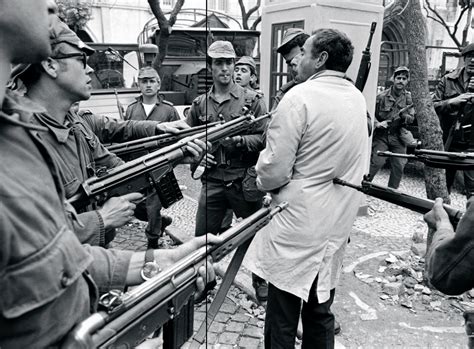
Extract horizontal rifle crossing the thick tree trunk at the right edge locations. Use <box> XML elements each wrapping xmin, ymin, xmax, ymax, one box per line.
<box><xmin>377</xmin><ymin>149</ymin><xmax>474</xmax><ymax>171</ymax></box>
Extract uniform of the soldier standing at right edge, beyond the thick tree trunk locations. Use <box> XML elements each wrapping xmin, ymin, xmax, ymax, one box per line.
<box><xmin>433</xmin><ymin>68</ymin><xmax>474</xmax><ymax>198</ymax></box>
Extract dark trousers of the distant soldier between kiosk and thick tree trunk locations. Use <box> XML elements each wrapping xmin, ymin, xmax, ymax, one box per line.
<box><xmin>369</xmin><ymin>131</ymin><xmax>407</xmax><ymax>189</ymax></box>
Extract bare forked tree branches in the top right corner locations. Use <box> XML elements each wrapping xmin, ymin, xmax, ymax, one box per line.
<box><xmin>423</xmin><ymin>0</ymin><xmax>472</xmax><ymax>51</ymax></box>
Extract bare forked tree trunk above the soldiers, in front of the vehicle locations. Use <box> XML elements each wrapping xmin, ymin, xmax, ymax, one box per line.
<box><xmin>148</xmin><ymin>0</ymin><xmax>184</xmax><ymax>72</ymax></box>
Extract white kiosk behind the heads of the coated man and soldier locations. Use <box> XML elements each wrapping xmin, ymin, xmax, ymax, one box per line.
<box><xmin>260</xmin><ymin>0</ymin><xmax>384</xmax><ymax>115</ymax></box>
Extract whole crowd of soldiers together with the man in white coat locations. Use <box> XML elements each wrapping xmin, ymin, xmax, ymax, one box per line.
<box><xmin>0</xmin><ymin>0</ymin><xmax>474</xmax><ymax>348</ymax></box>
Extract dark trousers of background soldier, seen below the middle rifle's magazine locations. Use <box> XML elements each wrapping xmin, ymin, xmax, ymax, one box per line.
<box><xmin>135</xmin><ymin>193</ymin><xmax>162</xmax><ymax>240</ymax></box>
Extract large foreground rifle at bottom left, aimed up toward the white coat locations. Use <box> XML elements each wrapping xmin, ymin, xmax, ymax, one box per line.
<box><xmin>64</xmin><ymin>202</ymin><xmax>288</xmax><ymax>349</ymax></box>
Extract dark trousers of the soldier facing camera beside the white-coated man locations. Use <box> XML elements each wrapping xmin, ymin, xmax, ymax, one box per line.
<box><xmin>195</xmin><ymin>179</ymin><xmax>262</xmax><ymax>236</ymax></box>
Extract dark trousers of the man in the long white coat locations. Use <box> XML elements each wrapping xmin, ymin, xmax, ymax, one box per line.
<box><xmin>265</xmin><ymin>277</ymin><xmax>335</xmax><ymax>349</ymax></box>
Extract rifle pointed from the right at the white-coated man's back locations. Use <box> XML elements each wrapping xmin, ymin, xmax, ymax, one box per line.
<box><xmin>333</xmin><ymin>178</ymin><xmax>463</xmax><ymax>229</ymax></box>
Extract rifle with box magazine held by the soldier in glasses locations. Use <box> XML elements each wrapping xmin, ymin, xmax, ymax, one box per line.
<box><xmin>68</xmin><ymin>112</ymin><xmax>272</xmax><ymax>210</ymax></box>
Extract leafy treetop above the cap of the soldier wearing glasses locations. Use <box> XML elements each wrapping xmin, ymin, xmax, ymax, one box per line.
<box><xmin>56</xmin><ymin>0</ymin><xmax>92</xmax><ymax>33</ymax></box>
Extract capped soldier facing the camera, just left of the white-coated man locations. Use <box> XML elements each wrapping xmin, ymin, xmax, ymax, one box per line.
<box><xmin>187</xmin><ymin>41</ymin><xmax>267</xmax><ymax>302</ymax></box>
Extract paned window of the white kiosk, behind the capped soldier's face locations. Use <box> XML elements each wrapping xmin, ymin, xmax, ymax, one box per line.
<box><xmin>270</xmin><ymin>21</ymin><xmax>304</xmax><ymax>100</ymax></box>
